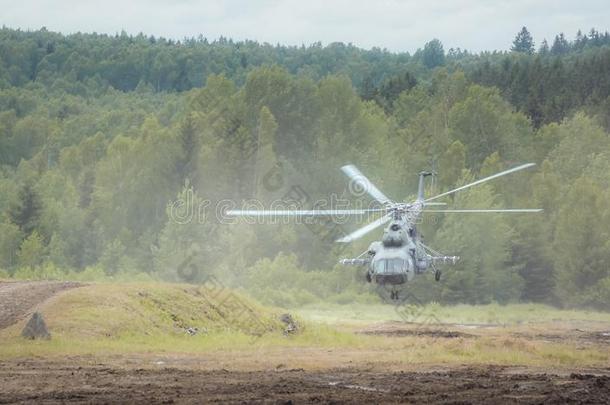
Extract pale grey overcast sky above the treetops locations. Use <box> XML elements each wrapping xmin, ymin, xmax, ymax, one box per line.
<box><xmin>0</xmin><ymin>0</ymin><xmax>610</xmax><ymax>52</ymax></box>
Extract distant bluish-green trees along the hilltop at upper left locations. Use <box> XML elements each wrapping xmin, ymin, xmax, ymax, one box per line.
<box><xmin>0</xmin><ymin>28</ymin><xmax>410</xmax><ymax>94</ymax></box>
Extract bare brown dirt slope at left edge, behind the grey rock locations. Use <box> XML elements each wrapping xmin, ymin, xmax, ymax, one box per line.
<box><xmin>0</xmin><ymin>281</ymin><xmax>81</xmax><ymax>329</ymax></box>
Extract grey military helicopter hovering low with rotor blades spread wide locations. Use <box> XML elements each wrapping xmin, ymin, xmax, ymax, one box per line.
<box><xmin>226</xmin><ymin>163</ymin><xmax>542</xmax><ymax>299</ymax></box>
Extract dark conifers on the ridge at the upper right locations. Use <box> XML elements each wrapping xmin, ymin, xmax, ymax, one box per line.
<box><xmin>368</xmin><ymin>27</ymin><xmax>610</xmax><ymax>129</ymax></box>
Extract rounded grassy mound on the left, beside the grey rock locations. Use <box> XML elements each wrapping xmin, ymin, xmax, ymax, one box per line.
<box><xmin>0</xmin><ymin>283</ymin><xmax>282</xmax><ymax>339</ymax></box>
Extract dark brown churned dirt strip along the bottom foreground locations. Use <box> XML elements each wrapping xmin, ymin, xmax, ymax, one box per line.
<box><xmin>0</xmin><ymin>361</ymin><xmax>610</xmax><ymax>404</ymax></box>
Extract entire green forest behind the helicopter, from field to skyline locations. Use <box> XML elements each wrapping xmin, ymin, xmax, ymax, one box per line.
<box><xmin>0</xmin><ymin>27</ymin><xmax>610</xmax><ymax>310</ymax></box>
